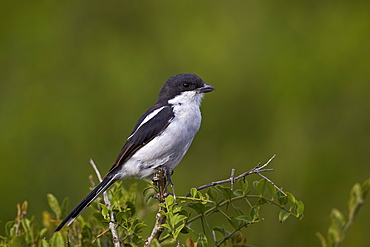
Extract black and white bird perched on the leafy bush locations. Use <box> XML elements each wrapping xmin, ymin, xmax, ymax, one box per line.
<box><xmin>55</xmin><ymin>73</ymin><xmax>215</xmax><ymax>232</ymax></box>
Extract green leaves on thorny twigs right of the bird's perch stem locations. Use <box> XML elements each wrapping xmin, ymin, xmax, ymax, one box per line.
<box><xmin>156</xmin><ymin>179</ymin><xmax>304</xmax><ymax>246</ymax></box>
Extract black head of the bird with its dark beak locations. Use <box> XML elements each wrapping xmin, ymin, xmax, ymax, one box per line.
<box><xmin>158</xmin><ymin>73</ymin><xmax>215</xmax><ymax>102</ymax></box>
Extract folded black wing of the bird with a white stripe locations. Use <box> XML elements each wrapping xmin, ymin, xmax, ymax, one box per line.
<box><xmin>109</xmin><ymin>104</ymin><xmax>174</xmax><ymax>171</ymax></box>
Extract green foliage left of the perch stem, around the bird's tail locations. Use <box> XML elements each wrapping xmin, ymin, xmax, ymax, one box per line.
<box><xmin>0</xmin><ymin>183</ymin><xmax>146</xmax><ymax>246</ymax></box>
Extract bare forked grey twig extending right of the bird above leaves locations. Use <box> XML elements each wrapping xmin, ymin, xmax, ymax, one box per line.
<box><xmin>185</xmin><ymin>154</ymin><xmax>286</xmax><ymax>197</ymax></box>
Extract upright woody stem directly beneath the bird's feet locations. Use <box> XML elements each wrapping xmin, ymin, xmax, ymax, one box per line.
<box><xmin>144</xmin><ymin>169</ymin><xmax>168</xmax><ymax>247</ymax></box>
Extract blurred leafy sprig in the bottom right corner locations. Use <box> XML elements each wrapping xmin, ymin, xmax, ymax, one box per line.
<box><xmin>316</xmin><ymin>179</ymin><xmax>370</xmax><ymax>247</ymax></box>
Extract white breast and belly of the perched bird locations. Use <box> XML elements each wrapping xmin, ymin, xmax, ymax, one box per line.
<box><xmin>119</xmin><ymin>92</ymin><xmax>202</xmax><ymax>178</ymax></box>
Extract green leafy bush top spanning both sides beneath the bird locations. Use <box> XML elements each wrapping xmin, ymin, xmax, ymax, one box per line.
<box><xmin>0</xmin><ymin>176</ymin><xmax>304</xmax><ymax>247</ymax></box>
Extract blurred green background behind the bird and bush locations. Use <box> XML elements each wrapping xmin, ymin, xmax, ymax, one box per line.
<box><xmin>0</xmin><ymin>0</ymin><xmax>370</xmax><ymax>246</ymax></box>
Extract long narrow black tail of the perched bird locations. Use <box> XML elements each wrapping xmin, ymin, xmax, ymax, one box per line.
<box><xmin>55</xmin><ymin>175</ymin><xmax>116</xmax><ymax>232</ymax></box>
